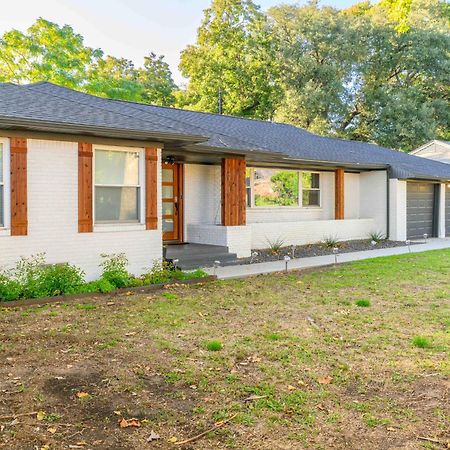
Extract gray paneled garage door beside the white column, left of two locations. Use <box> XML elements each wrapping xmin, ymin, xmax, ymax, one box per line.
<box><xmin>406</xmin><ymin>183</ymin><xmax>434</xmax><ymax>239</ymax></box>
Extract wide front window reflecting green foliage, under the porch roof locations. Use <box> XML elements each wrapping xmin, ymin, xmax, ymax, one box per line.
<box><xmin>246</xmin><ymin>168</ymin><xmax>321</xmax><ymax>208</ymax></box>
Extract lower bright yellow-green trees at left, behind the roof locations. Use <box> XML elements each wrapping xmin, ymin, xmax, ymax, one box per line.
<box><xmin>0</xmin><ymin>18</ymin><xmax>176</xmax><ymax>105</ymax></box>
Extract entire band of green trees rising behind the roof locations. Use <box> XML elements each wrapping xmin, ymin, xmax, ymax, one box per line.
<box><xmin>0</xmin><ymin>0</ymin><xmax>450</xmax><ymax>151</ymax></box>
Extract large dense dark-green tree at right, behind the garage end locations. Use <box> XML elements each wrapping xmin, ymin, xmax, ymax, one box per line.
<box><xmin>269</xmin><ymin>0</ymin><xmax>450</xmax><ymax>150</ymax></box>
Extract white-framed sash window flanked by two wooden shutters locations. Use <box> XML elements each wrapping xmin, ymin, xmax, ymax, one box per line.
<box><xmin>93</xmin><ymin>146</ymin><xmax>144</xmax><ymax>224</ymax></box>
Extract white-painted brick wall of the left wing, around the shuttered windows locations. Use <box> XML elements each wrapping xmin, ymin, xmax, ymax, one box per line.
<box><xmin>0</xmin><ymin>139</ymin><xmax>162</xmax><ymax>279</ymax></box>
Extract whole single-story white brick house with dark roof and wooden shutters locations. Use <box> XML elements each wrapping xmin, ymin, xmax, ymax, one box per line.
<box><xmin>0</xmin><ymin>82</ymin><xmax>450</xmax><ymax>278</ymax></box>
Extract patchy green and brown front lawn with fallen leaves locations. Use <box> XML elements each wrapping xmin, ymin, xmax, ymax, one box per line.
<box><xmin>0</xmin><ymin>250</ymin><xmax>450</xmax><ymax>450</ymax></box>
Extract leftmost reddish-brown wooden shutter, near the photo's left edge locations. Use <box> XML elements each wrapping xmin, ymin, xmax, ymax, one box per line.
<box><xmin>10</xmin><ymin>137</ymin><xmax>28</xmax><ymax>236</ymax></box>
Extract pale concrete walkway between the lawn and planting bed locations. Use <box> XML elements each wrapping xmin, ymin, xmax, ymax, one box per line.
<box><xmin>205</xmin><ymin>238</ymin><xmax>450</xmax><ymax>279</ymax></box>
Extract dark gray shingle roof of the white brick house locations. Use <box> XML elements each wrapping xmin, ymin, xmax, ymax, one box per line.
<box><xmin>0</xmin><ymin>82</ymin><xmax>450</xmax><ymax>180</ymax></box>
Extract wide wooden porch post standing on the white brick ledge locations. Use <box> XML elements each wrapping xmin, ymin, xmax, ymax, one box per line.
<box><xmin>222</xmin><ymin>158</ymin><xmax>247</xmax><ymax>226</ymax></box>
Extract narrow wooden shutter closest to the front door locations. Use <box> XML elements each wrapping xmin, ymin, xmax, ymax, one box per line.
<box><xmin>145</xmin><ymin>148</ymin><xmax>158</xmax><ymax>230</ymax></box>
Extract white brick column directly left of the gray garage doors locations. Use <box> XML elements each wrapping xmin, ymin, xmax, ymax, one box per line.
<box><xmin>389</xmin><ymin>178</ymin><xmax>407</xmax><ymax>241</ymax></box>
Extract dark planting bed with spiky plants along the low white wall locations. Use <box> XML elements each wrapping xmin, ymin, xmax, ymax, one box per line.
<box><xmin>239</xmin><ymin>239</ymin><xmax>415</xmax><ymax>264</ymax></box>
